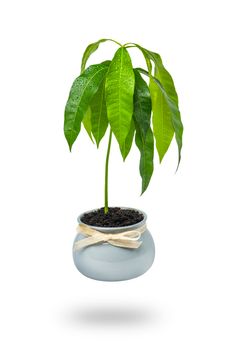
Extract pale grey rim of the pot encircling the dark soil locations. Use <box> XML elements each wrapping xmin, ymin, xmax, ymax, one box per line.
<box><xmin>77</xmin><ymin>206</ymin><xmax>147</xmax><ymax>233</ymax></box>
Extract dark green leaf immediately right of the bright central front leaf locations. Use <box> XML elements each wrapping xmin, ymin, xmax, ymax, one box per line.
<box><xmin>133</xmin><ymin>69</ymin><xmax>151</xmax><ymax>139</ymax></box>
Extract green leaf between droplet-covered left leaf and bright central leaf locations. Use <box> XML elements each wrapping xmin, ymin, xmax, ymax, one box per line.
<box><xmin>91</xmin><ymin>79</ymin><xmax>108</xmax><ymax>147</ymax></box>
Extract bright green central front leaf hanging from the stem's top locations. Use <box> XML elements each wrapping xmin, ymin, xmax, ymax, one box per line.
<box><xmin>106</xmin><ymin>47</ymin><xmax>135</xmax><ymax>149</ymax></box>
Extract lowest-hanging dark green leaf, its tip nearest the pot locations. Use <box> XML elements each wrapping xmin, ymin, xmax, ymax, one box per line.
<box><xmin>135</xmin><ymin>125</ymin><xmax>154</xmax><ymax>194</ymax></box>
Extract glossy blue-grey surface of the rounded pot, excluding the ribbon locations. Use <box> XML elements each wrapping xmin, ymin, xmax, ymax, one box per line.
<box><xmin>73</xmin><ymin>208</ymin><xmax>155</xmax><ymax>281</ymax></box>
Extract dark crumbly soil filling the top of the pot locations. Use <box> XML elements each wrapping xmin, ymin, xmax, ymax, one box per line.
<box><xmin>81</xmin><ymin>208</ymin><xmax>144</xmax><ymax>227</ymax></box>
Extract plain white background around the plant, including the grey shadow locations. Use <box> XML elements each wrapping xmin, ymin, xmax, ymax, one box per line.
<box><xmin>0</xmin><ymin>0</ymin><xmax>234</xmax><ymax>350</ymax></box>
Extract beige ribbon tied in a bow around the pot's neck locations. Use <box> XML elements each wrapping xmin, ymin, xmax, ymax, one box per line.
<box><xmin>74</xmin><ymin>224</ymin><xmax>146</xmax><ymax>251</ymax></box>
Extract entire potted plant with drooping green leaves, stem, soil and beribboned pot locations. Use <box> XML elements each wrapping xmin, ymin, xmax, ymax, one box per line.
<box><xmin>64</xmin><ymin>39</ymin><xmax>183</xmax><ymax>281</ymax></box>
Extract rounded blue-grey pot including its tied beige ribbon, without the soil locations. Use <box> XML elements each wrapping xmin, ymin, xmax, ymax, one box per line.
<box><xmin>73</xmin><ymin>208</ymin><xmax>155</xmax><ymax>282</ymax></box>
